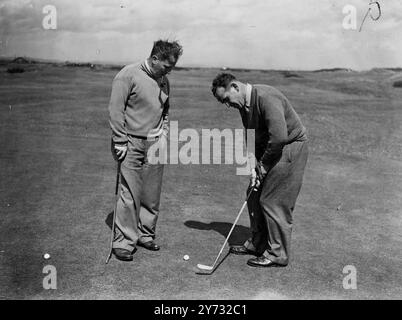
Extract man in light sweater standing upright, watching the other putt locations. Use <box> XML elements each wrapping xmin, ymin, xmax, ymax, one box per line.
<box><xmin>109</xmin><ymin>40</ymin><xmax>183</xmax><ymax>261</ymax></box>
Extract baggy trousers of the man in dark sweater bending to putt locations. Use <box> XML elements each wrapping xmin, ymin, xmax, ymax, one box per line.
<box><xmin>245</xmin><ymin>141</ymin><xmax>308</xmax><ymax>265</ymax></box>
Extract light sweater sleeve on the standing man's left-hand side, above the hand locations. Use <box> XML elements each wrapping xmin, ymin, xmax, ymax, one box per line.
<box><xmin>109</xmin><ymin>78</ymin><xmax>131</xmax><ymax>145</ymax></box>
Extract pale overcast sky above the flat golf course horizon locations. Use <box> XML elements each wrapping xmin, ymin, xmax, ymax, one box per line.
<box><xmin>0</xmin><ymin>0</ymin><xmax>402</xmax><ymax>69</ymax></box>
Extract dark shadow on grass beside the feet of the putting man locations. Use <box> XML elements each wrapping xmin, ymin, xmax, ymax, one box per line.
<box><xmin>184</xmin><ymin>220</ymin><xmax>250</xmax><ymax>245</ymax></box>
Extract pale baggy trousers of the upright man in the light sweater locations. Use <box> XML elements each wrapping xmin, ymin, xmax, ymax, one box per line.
<box><xmin>113</xmin><ymin>137</ymin><xmax>163</xmax><ymax>251</ymax></box>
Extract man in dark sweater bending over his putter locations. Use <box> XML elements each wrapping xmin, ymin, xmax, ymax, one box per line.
<box><xmin>212</xmin><ymin>73</ymin><xmax>308</xmax><ymax>267</ymax></box>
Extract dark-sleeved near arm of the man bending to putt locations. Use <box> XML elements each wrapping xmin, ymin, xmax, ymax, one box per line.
<box><xmin>256</xmin><ymin>97</ymin><xmax>288</xmax><ymax>177</ymax></box>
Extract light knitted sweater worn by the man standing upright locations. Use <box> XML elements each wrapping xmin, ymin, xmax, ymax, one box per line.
<box><xmin>109</xmin><ymin>62</ymin><xmax>170</xmax><ymax>144</ymax></box>
